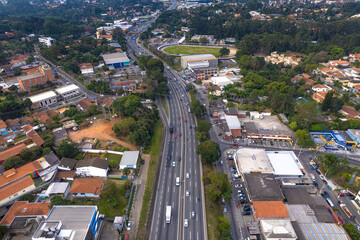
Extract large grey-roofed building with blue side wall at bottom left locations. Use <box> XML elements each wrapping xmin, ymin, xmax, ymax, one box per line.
<box><xmin>32</xmin><ymin>205</ymin><xmax>102</xmax><ymax>240</ymax></box>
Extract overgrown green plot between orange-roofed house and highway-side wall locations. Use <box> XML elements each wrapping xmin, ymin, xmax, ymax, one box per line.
<box><xmin>97</xmin><ymin>180</ymin><xmax>129</xmax><ymax>217</ymax></box>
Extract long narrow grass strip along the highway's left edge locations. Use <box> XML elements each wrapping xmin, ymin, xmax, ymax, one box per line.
<box><xmin>136</xmin><ymin>120</ymin><xmax>164</xmax><ymax>239</ymax></box>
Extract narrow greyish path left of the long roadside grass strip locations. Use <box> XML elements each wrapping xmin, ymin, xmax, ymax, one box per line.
<box><xmin>125</xmin><ymin>154</ymin><xmax>150</xmax><ymax>240</ymax></box>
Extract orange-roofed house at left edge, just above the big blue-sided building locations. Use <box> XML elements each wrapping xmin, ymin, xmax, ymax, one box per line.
<box><xmin>0</xmin><ymin>201</ymin><xmax>51</xmax><ymax>227</ymax></box>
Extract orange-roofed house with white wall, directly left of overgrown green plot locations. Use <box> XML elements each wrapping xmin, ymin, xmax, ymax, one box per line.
<box><xmin>69</xmin><ymin>178</ymin><xmax>105</xmax><ymax>197</ymax></box>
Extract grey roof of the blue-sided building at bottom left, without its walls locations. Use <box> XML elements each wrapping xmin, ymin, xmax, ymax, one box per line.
<box><xmin>33</xmin><ymin>205</ymin><xmax>98</xmax><ymax>240</ymax></box>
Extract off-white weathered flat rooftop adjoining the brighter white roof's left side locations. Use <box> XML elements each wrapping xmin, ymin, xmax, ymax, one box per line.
<box><xmin>236</xmin><ymin>148</ymin><xmax>274</xmax><ymax>174</ymax></box>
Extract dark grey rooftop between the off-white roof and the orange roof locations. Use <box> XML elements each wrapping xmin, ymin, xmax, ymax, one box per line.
<box><xmin>244</xmin><ymin>173</ymin><xmax>284</xmax><ymax>201</ymax></box>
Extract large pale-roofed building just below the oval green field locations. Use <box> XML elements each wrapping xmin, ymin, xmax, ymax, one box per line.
<box><xmin>181</xmin><ymin>54</ymin><xmax>218</xmax><ymax>69</ymax></box>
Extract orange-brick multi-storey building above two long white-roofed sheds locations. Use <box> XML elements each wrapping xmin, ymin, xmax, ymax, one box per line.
<box><xmin>17</xmin><ymin>65</ymin><xmax>55</xmax><ymax>91</ymax></box>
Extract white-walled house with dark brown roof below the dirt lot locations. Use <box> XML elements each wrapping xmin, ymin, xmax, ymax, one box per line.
<box><xmin>75</xmin><ymin>157</ymin><xmax>109</xmax><ymax>177</ymax></box>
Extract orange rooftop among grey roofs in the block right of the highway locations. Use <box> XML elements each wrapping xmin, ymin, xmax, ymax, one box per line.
<box><xmin>253</xmin><ymin>201</ymin><xmax>289</xmax><ymax>218</ymax></box>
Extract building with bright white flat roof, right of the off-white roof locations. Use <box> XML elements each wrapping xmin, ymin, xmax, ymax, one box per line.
<box><xmin>266</xmin><ymin>151</ymin><xmax>304</xmax><ymax>178</ymax></box>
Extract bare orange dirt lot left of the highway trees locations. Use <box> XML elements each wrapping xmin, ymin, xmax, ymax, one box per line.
<box><xmin>69</xmin><ymin>119</ymin><xmax>139</xmax><ymax>150</ymax></box>
